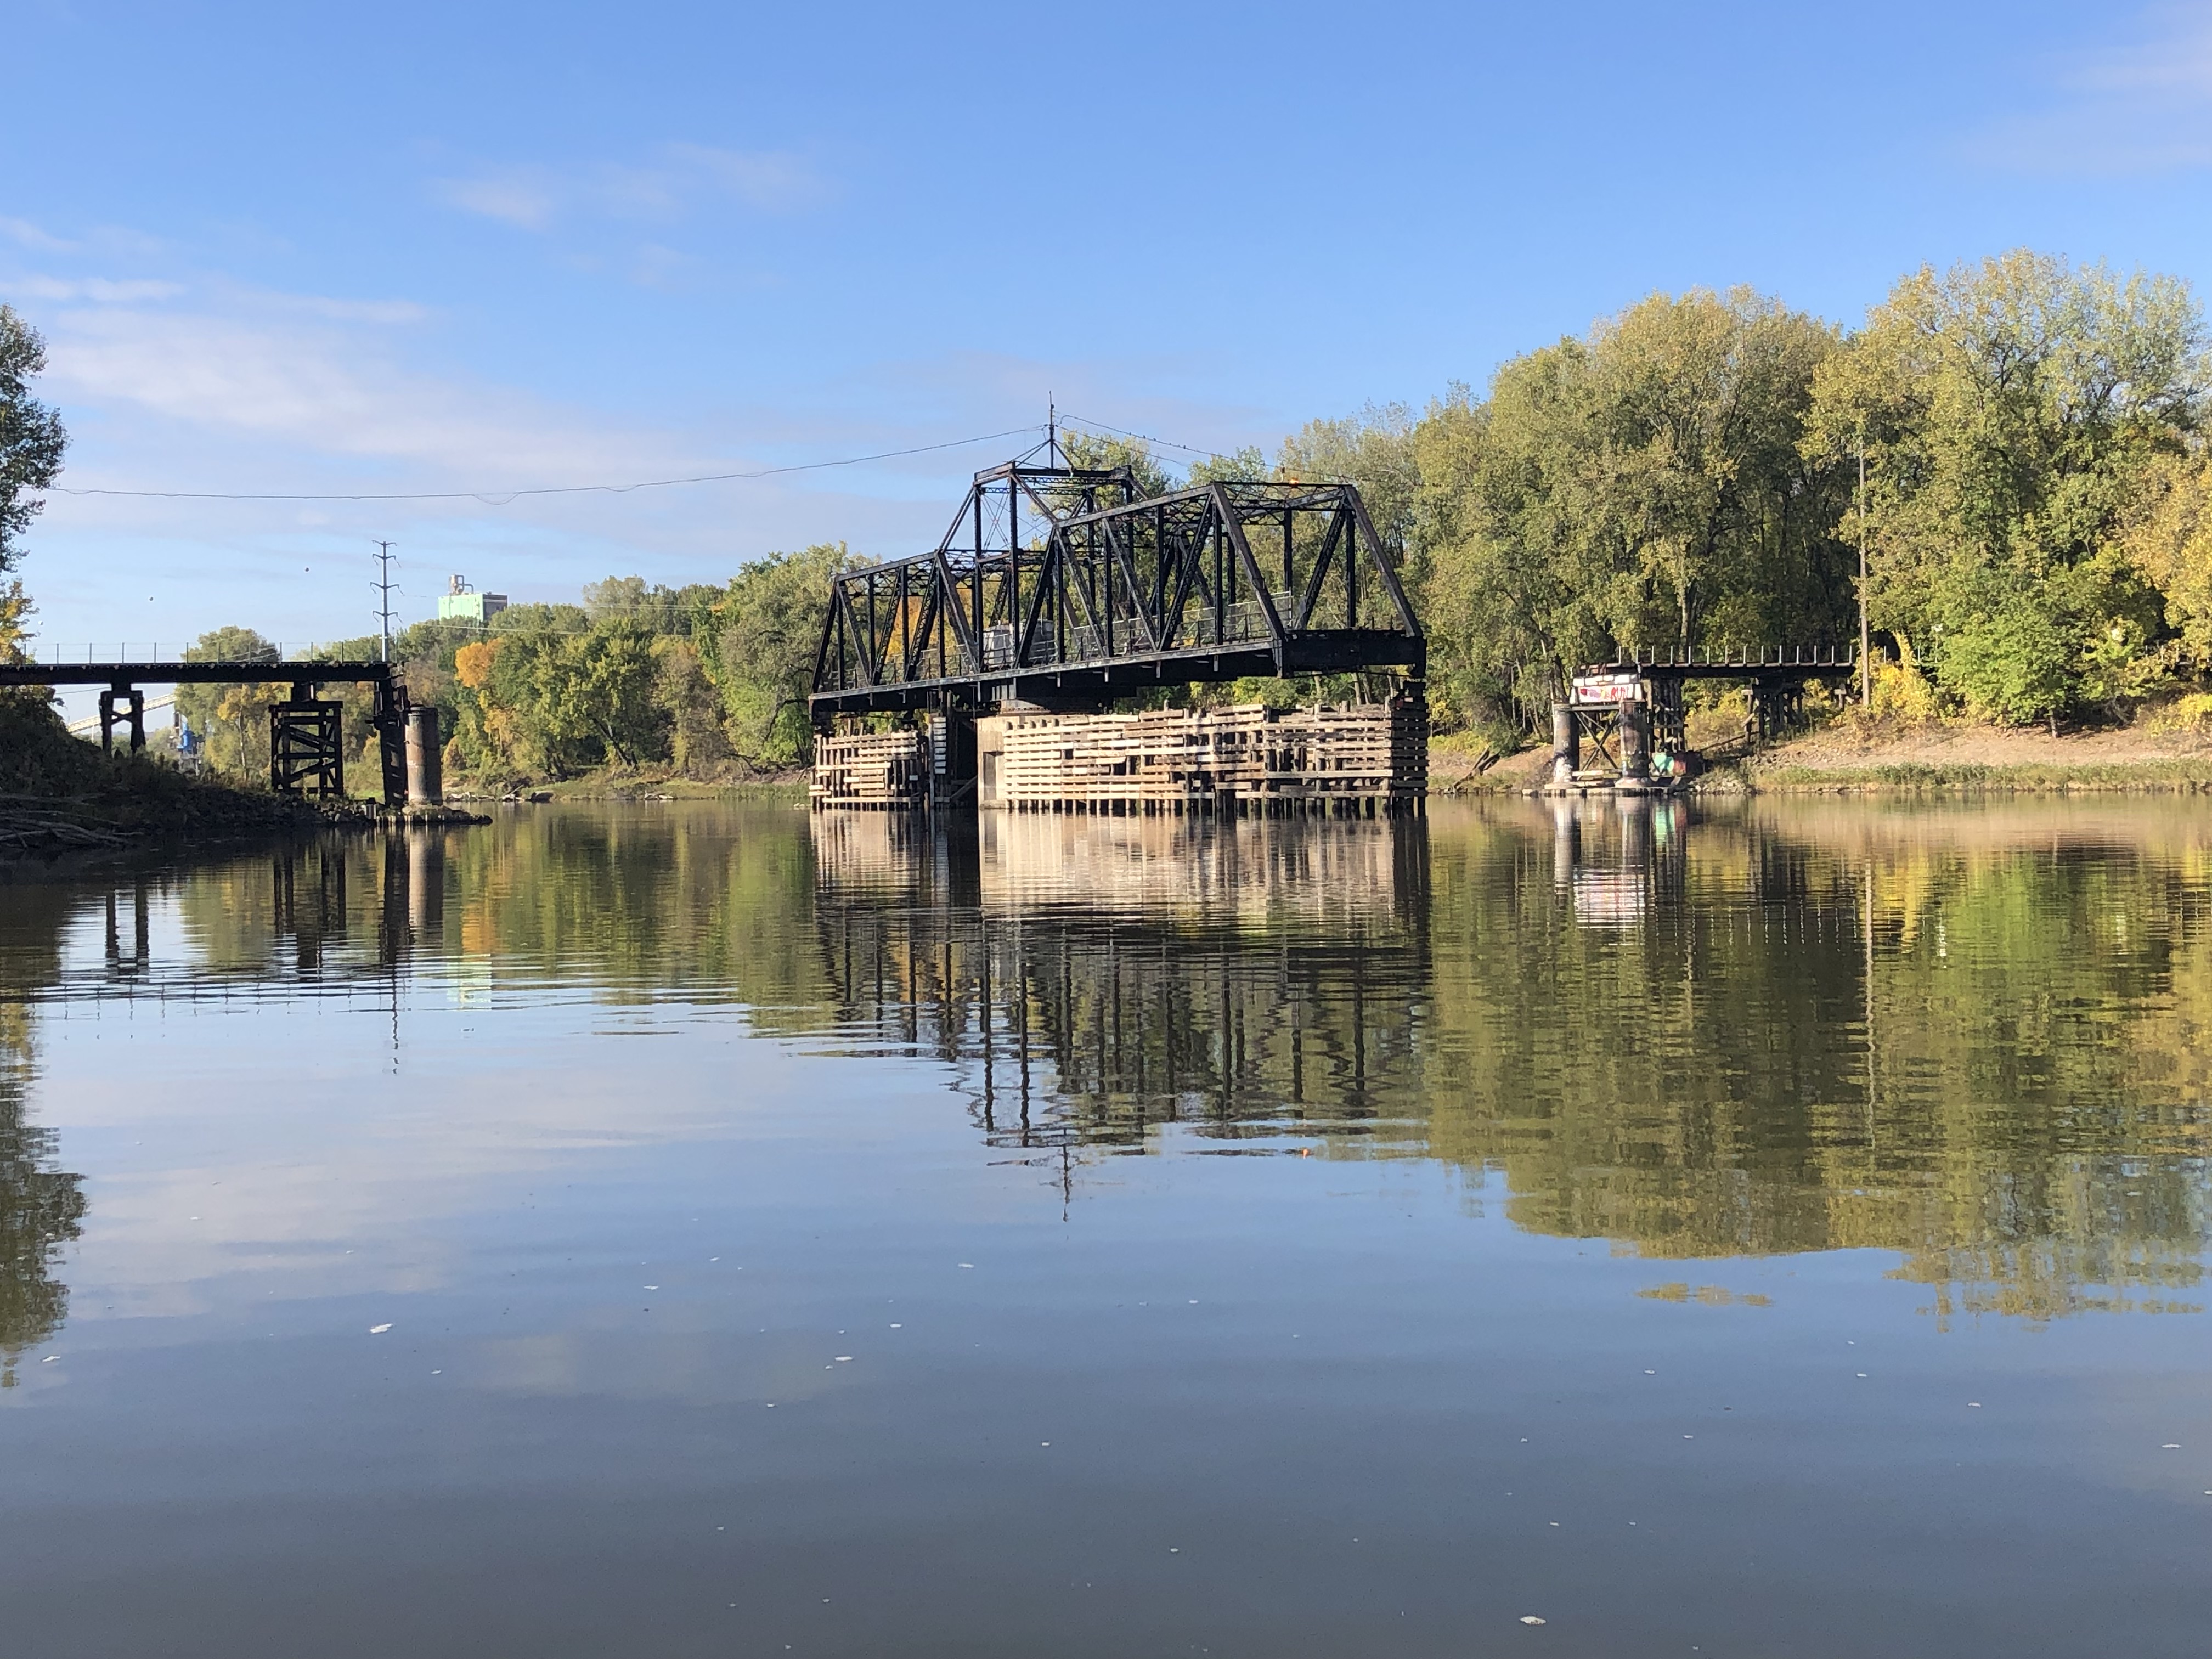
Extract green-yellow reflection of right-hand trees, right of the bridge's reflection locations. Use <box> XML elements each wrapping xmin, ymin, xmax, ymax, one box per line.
<box><xmin>1425</xmin><ymin>808</ymin><xmax>2212</xmax><ymax>1318</ymax></box>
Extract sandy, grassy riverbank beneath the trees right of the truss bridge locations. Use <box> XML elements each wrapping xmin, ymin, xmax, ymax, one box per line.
<box><xmin>1429</xmin><ymin>723</ymin><xmax>2212</xmax><ymax>794</ymax></box>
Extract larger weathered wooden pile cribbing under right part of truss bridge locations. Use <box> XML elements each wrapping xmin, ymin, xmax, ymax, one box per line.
<box><xmin>978</xmin><ymin>697</ymin><xmax>1429</xmax><ymax>819</ymax></box>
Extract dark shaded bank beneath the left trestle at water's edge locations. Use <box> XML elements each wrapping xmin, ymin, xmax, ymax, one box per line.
<box><xmin>0</xmin><ymin>695</ymin><xmax>323</xmax><ymax>881</ymax></box>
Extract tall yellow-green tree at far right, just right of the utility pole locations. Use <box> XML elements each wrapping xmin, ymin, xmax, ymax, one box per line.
<box><xmin>1803</xmin><ymin>250</ymin><xmax>2208</xmax><ymax>721</ymax></box>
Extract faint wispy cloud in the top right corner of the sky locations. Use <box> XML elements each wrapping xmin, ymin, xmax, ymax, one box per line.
<box><xmin>1966</xmin><ymin>0</ymin><xmax>2212</xmax><ymax>175</ymax></box>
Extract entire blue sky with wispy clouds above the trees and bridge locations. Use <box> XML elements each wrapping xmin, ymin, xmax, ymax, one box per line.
<box><xmin>0</xmin><ymin>0</ymin><xmax>2212</xmax><ymax>641</ymax></box>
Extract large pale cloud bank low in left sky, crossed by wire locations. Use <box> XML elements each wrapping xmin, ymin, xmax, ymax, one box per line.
<box><xmin>0</xmin><ymin>239</ymin><xmax>1274</xmax><ymax>641</ymax></box>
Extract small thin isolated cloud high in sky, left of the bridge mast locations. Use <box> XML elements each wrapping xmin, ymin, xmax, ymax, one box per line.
<box><xmin>431</xmin><ymin>144</ymin><xmax>830</xmax><ymax>230</ymax></box>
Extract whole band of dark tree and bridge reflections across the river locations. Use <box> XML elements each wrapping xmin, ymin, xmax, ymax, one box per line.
<box><xmin>0</xmin><ymin>801</ymin><xmax>2212</xmax><ymax>1352</ymax></box>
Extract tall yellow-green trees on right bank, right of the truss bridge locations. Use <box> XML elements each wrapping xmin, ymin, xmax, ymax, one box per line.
<box><xmin>1407</xmin><ymin>252</ymin><xmax>2212</xmax><ymax>725</ymax></box>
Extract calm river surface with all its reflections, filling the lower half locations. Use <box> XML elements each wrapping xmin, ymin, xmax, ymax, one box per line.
<box><xmin>0</xmin><ymin>801</ymin><xmax>2212</xmax><ymax>1659</ymax></box>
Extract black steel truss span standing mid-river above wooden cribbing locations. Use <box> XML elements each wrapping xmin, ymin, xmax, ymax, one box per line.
<box><xmin>810</xmin><ymin>442</ymin><xmax>1427</xmax><ymax>725</ymax></box>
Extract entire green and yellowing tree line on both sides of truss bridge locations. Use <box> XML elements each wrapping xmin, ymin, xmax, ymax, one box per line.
<box><xmin>13</xmin><ymin>250</ymin><xmax>2212</xmax><ymax>778</ymax></box>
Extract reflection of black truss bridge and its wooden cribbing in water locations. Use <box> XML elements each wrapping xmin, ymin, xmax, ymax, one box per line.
<box><xmin>812</xmin><ymin>814</ymin><xmax>1427</xmax><ymax>1150</ymax></box>
